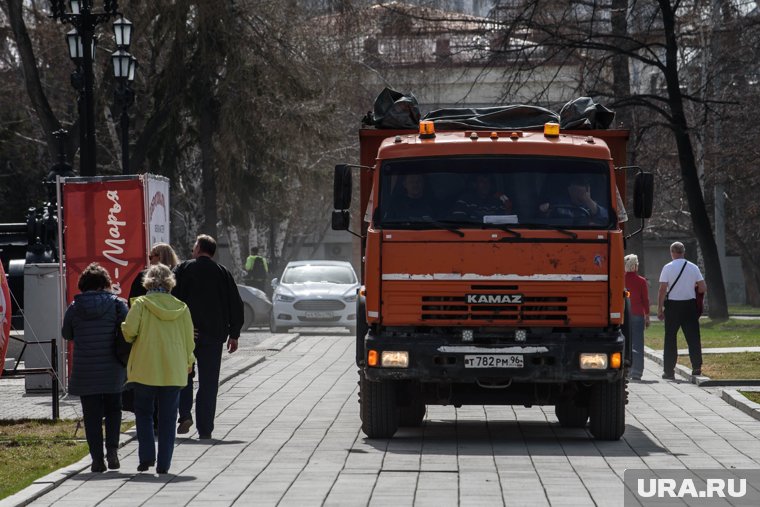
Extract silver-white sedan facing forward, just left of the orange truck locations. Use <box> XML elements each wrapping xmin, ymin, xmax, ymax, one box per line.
<box><xmin>269</xmin><ymin>261</ymin><xmax>359</xmax><ymax>333</ymax></box>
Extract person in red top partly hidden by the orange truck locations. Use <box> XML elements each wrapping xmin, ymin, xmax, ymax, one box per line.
<box><xmin>625</xmin><ymin>254</ymin><xmax>649</xmax><ymax>380</ymax></box>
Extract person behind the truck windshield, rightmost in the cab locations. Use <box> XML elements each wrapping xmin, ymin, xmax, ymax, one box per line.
<box><xmin>538</xmin><ymin>174</ymin><xmax>610</xmax><ymax>225</ymax></box>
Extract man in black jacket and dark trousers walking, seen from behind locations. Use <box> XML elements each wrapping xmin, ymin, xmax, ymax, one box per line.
<box><xmin>172</xmin><ymin>234</ymin><xmax>243</xmax><ymax>440</ymax></box>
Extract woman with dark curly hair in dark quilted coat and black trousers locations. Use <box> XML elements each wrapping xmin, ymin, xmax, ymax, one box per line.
<box><xmin>61</xmin><ymin>262</ymin><xmax>128</xmax><ymax>472</ymax></box>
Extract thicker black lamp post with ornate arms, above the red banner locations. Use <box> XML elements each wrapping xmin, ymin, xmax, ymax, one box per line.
<box><xmin>50</xmin><ymin>0</ymin><xmax>127</xmax><ymax>176</ymax></box>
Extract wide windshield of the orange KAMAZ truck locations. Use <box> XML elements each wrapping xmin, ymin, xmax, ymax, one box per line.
<box><xmin>374</xmin><ymin>156</ymin><xmax>616</xmax><ymax>229</ymax></box>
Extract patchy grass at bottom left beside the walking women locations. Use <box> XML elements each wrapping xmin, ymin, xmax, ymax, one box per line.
<box><xmin>0</xmin><ymin>420</ymin><xmax>134</xmax><ymax>499</ymax></box>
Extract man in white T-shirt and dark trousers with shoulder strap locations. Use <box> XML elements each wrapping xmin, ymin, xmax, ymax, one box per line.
<box><xmin>657</xmin><ymin>241</ymin><xmax>707</xmax><ymax>380</ymax></box>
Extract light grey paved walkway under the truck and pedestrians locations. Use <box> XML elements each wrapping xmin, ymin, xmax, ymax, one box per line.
<box><xmin>0</xmin><ymin>334</ymin><xmax>760</xmax><ymax>507</ymax></box>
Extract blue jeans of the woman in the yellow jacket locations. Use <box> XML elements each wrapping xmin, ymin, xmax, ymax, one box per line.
<box><xmin>135</xmin><ymin>384</ymin><xmax>181</xmax><ymax>471</ymax></box>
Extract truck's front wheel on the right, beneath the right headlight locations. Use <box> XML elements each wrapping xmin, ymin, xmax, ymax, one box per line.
<box><xmin>589</xmin><ymin>378</ymin><xmax>626</xmax><ymax>440</ymax></box>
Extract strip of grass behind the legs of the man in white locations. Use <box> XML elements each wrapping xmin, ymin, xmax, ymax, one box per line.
<box><xmin>644</xmin><ymin>317</ymin><xmax>760</xmax><ymax>350</ymax></box>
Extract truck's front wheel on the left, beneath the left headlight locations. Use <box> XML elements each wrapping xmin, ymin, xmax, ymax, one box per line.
<box><xmin>359</xmin><ymin>373</ymin><xmax>398</xmax><ymax>438</ymax></box>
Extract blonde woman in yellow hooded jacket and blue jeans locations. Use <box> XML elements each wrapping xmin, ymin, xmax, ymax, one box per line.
<box><xmin>121</xmin><ymin>264</ymin><xmax>195</xmax><ymax>474</ymax></box>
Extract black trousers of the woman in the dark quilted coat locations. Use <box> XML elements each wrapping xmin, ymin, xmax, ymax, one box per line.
<box><xmin>79</xmin><ymin>393</ymin><xmax>121</xmax><ymax>461</ymax></box>
